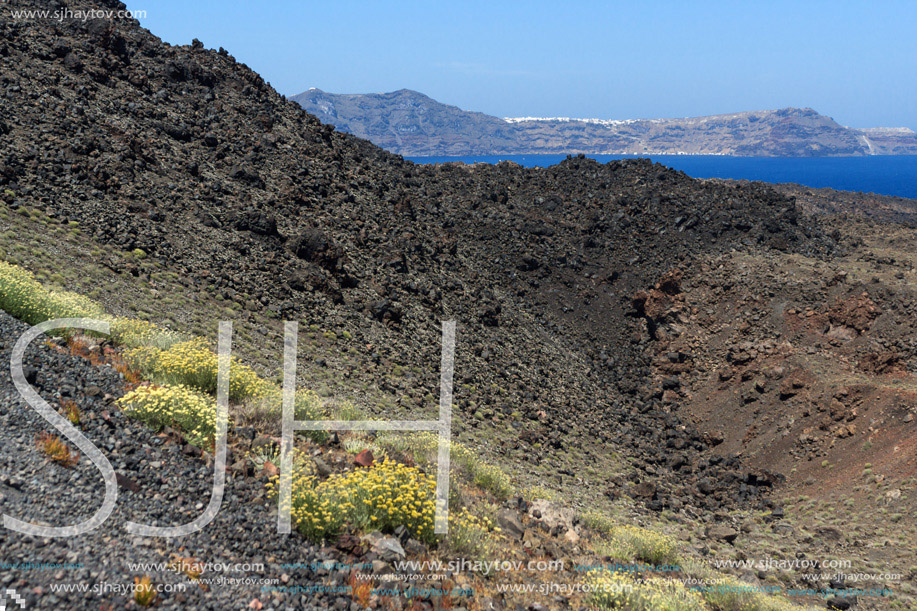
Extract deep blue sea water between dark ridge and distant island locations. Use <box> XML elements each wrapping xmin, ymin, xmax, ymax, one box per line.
<box><xmin>407</xmin><ymin>155</ymin><xmax>917</xmax><ymax>199</ymax></box>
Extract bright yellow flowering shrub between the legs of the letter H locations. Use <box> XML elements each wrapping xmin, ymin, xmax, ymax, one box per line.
<box><xmin>268</xmin><ymin>460</ymin><xmax>436</xmax><ymax>542</ymax></box>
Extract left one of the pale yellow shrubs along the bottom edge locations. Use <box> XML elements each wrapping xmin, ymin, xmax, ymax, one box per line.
<box><xmin>586</xmin><ymin>571</ymin><xmax>707</xmax><ymax>611</ymax></box>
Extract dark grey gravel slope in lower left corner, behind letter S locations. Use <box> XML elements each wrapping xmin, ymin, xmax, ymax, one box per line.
<box><xmin>0</xmin><ymin>312</ymin><xmax>360</xmax><ymax>611</ymax></box>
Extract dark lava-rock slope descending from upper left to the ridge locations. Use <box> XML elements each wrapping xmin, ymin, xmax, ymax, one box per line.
<box><xmin>0</xmin><ymin>0</ymin><xmax>830</xmax><ymax>520</ymax></box>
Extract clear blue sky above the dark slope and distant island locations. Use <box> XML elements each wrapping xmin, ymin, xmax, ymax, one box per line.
<box><xmin>127</xmin><ymin>0</ymin><xmax>917</xmax><ymax>129</ymax></box>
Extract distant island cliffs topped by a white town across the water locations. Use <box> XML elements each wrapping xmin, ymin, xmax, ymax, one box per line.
<box><xmin>292</xmin><ymin>89</ymin><xmax>917</xmax><ymax>157</ymax></box>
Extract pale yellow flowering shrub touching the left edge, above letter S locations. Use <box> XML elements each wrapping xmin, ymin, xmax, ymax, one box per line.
<box><xmin>0</xmin><ymin>261</ymin><xmax>103</xmax><ymax>325</ymax></box>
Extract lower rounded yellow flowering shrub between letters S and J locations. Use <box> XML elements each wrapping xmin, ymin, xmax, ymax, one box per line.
<box><xmin>118</xmin><ymin>386</ymin><xmax>216</xmax><ymax>446</ymax></box>
